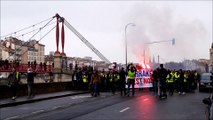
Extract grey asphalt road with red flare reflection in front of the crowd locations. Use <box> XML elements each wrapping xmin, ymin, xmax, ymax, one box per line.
<box><xmin>1</xmin><ymin>91</ymin><xmax>209</xmax><ymax>120</ymax></box>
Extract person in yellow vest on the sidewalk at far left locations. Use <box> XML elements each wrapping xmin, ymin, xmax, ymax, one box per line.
<box><xmin>8</xmin><ymin>68</ymin><xmax>20</xmax><ymax>100</ymax></box>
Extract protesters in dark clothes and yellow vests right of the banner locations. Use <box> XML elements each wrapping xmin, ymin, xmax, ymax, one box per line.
<box><xmin>152</xmin><ymin>64</ymin><xmax>200</xmax><ymax>98</ymax></box>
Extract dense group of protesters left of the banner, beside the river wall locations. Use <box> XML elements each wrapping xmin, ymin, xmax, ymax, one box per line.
<box><xmin>72</xmin><ymin>64</ymin><xmax>136</xmax><ymax>96</ymax></box>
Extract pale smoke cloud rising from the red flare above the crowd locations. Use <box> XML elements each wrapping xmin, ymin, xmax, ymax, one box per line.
<box><xmin>124</xmin><ymin>4</ymin><xmax>208</xmax><ymax>62</ymax></box>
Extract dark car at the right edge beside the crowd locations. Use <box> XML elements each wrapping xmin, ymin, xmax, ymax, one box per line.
<box><xmin>199</xmin><ymin>73</ymin><xmax>213</xmax><ymax>92</ymax></box>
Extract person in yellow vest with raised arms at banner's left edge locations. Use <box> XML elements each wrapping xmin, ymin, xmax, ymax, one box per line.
<box><xmin>127</xmin><ymin>66</ymin><xmax>136</xmax><ymax>96</ymax></box>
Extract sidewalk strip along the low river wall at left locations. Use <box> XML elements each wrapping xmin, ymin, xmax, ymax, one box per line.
<box><xmin>0</xmin><ymin>91</ymin><xmax>88</xmax><ymax>108</ymax></box>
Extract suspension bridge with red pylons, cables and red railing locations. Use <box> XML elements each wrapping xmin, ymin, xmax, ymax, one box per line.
<box><xmin>0</xmin><ymin>14</ymin><xmax>110</xmax><ymax>74</ymax></box>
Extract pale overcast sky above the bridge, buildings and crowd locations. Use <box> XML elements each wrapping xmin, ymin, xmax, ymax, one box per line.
<box><xmin>0</xmin><ymin>0</ymin><xmax>213</xmax><ymax>63</ymax></box>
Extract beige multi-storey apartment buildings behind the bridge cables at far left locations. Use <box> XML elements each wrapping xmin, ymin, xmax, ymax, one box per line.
<box><xmin>0</xmin><ymin>37</ymin><xmax>45</xmax><ymax>64</ymax></box>
